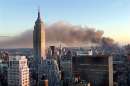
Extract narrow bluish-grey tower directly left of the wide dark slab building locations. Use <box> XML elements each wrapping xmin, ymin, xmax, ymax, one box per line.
<box><xmin>60</xmin><ymin>51</ymin><xmax>72</xmax><ymax>86</ymax></box>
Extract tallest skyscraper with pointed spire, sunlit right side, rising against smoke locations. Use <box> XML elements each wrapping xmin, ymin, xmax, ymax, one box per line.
<box><xmin>33</xmin><ymin>11</ymin><xmax>46</xmax><ymax>65</ymax></box>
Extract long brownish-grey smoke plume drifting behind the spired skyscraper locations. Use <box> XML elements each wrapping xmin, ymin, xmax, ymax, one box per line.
<box><xmin>0</xmin><ymin>22</ymin><xmax>114</xmax><ymax>48</ymax></box>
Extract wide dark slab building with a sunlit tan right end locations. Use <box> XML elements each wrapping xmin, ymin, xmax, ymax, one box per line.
<box><xmin>72</xmin><ymin>56</ymin><xmax>113</xmax><ymax>86</ymax></box>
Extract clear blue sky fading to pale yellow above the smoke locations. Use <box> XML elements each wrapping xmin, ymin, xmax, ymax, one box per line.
<box><xmin>0</xmin><ymin>0</ymin><xmax>130</xmax><ymax>44</ymax></box>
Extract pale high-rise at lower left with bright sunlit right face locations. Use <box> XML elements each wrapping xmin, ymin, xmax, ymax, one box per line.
<box><xmin>8</xmin><ymin>56</ymin><xmax>30</xmax><ymax>86</ymax></box>
